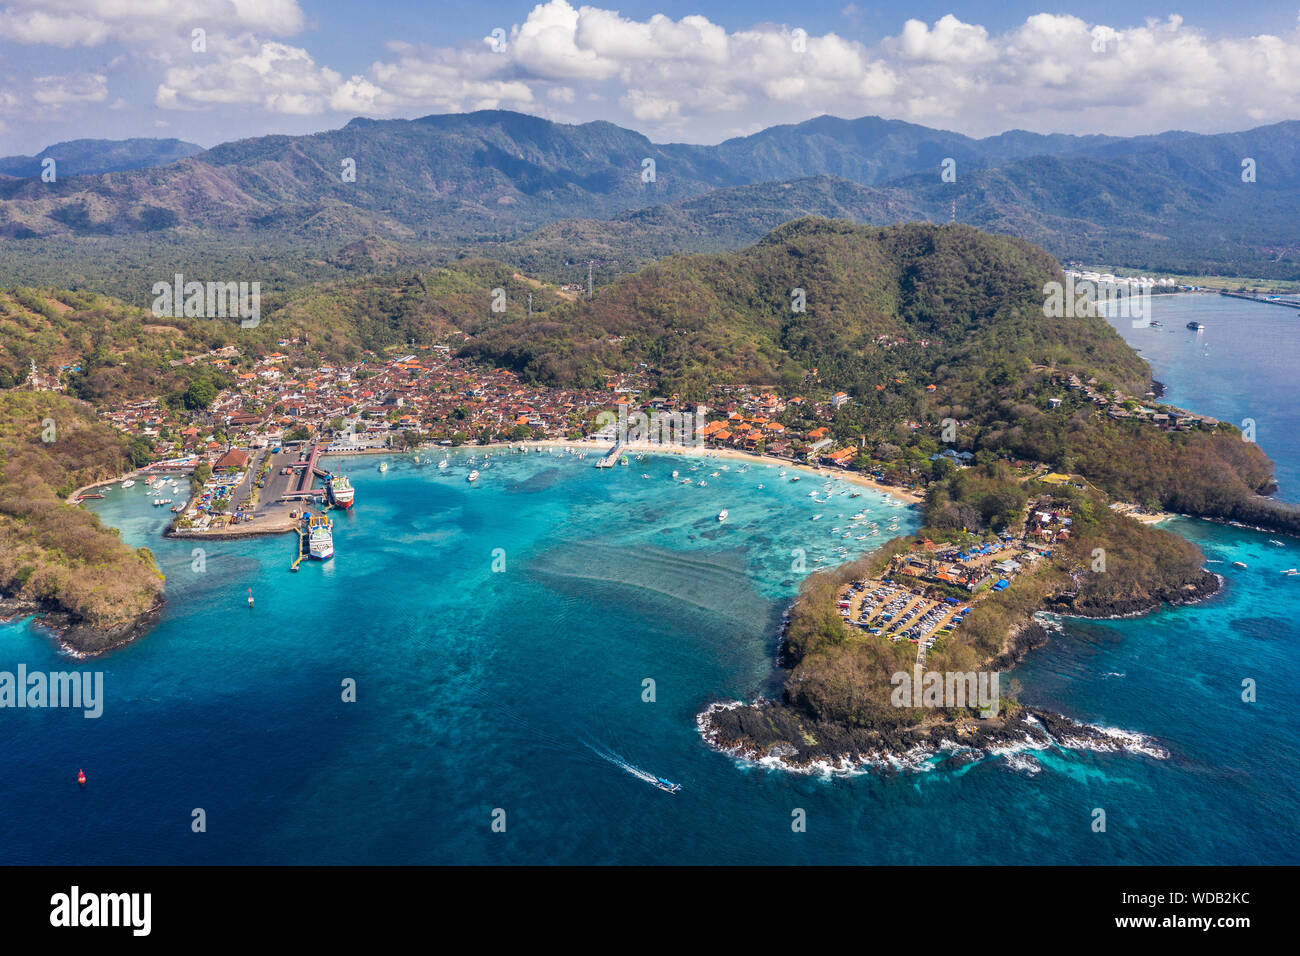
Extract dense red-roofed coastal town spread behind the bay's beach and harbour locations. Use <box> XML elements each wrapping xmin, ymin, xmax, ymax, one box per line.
<box><xmin>25</xmin><ymin>306</ymin><xmax>1218</xmax><ymax>546</ymax></box>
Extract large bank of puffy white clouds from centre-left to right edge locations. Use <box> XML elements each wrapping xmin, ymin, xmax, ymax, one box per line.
<box><xmin>334</xmin><ymin>0</ymin><xmax>1300</xmax><ymax>142</ymax></box>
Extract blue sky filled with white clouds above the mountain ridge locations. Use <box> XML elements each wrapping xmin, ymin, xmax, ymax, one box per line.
<box><xmin>0</xmin><ymin>0</ymin><xmax>1300</xmax><ymax>155</ymax></box>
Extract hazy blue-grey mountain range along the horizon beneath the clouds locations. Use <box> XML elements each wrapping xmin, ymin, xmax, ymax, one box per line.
<box><xmin>0</xmin><ymin>111</ymin><xmax>1300</xmax><ymax>302</ymax></box>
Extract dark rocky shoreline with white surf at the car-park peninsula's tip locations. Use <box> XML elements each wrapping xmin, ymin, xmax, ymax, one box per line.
<box><xmin>696</xmin><ymin>698</ymin><xmax>1169</xmax><ymax>774</ymax></box>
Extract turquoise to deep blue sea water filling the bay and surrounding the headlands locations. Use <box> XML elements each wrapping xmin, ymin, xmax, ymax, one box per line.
<box><xmin>0</xmin><ymin>297</ymin><xmax>1300</xmax><ymax>864</ymax></box>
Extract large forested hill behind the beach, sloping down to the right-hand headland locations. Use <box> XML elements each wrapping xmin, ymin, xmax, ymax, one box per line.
<box><xmin>467</xmin><ymin>219</ymin><xmax>1300</xmax><ymax>531</ymax></box>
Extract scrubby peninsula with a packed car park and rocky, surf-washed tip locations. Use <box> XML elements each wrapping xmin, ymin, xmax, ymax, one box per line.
<box><xmin>698</xmin><ymin>463</ymin><xmax>1221</xmax><ymax>770</ymax></box>
